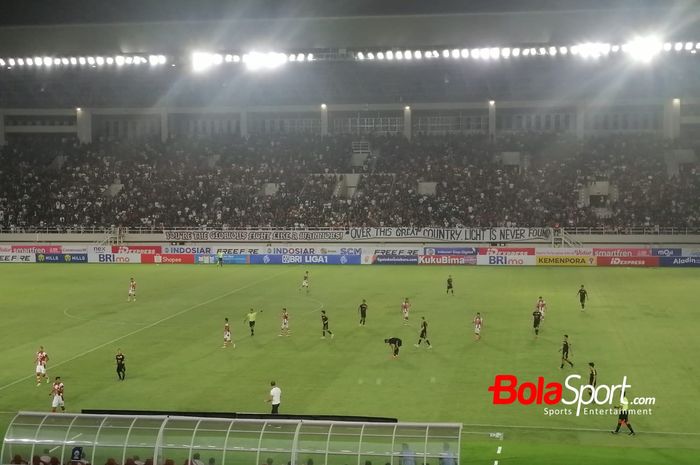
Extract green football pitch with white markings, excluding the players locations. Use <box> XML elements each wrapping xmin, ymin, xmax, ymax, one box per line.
<box><xmin>0</xmin><ymin>264</ymin><xmax>700</xmax><ymax>465</ymax></box>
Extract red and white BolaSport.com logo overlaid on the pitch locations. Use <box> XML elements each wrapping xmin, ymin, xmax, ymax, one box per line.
<box><xmin>488</xmin><ymin>374</ymin><xmax>656</xmax><ymax>416</ymax></box>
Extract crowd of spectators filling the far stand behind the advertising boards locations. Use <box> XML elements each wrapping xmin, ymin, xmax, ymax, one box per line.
<box><xmin>0</xmin><ymin>134</ymin><xmax>700</xmax><ymax>231</ymax></box>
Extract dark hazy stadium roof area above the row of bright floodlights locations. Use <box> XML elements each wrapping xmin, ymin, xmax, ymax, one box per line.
<box><xmin>0</xmin><ymin>0</ymin><xmax>700</xmax><ymax>56</ymax></box>
